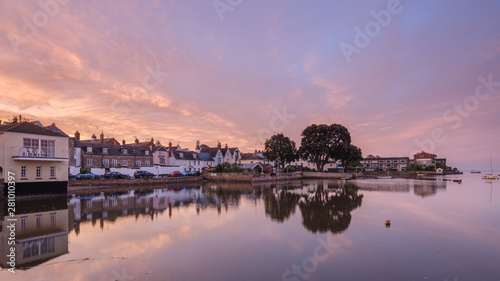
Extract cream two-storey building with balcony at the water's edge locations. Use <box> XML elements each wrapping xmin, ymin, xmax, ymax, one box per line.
<box><xmin>0</xmin><ymin>118</ymin><xmax>68</xmax><ymax>195</ymax></box>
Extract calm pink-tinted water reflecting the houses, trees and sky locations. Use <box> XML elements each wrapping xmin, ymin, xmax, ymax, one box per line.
<box><xmin>0</xmin><ymin>174</ymin><xmax>500</xmax><ymax>281</ymax></box>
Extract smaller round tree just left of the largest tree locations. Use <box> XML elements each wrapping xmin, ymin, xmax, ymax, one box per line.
<box><xmin>264</xmin><ymin>134</ymin><xmax>297</xmax><ymax>164</ymax></box>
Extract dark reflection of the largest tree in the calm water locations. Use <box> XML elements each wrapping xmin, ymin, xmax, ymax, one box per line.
<box><xmin>299</xmin><ymin>185</ymin><xmax>363</xmax><ymax>233</ymax></box>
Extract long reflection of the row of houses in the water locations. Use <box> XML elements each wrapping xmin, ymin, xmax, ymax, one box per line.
<box><xmin>68</xmin><ymin>187</ymin><xmax>243</xmax><ymax>234</ymax></box>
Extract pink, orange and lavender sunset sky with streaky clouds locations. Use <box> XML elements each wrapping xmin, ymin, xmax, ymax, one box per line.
<box><xmin>0</xmin><ymin>0</ymin><xmax>500</xmax><ymax>170</ymax></box>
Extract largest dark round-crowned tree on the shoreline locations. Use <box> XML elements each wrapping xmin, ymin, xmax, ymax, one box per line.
<box><xmin>299</xmin><ymin>124</ymin><xmax>351</xmax><ymax>171</ymax></box>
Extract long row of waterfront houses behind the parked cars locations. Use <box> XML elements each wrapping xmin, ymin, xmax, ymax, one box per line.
<box><xmin>69</xmin><ymin>131</ymin><xmax>241</xmax><ymax>171</ymax></box>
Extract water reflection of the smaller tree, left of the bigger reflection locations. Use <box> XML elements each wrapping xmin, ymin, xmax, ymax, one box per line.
<box><xmin>263</xmin><ymin>189</ymin><xmax>300</xmax><ymax>222</ymax></box>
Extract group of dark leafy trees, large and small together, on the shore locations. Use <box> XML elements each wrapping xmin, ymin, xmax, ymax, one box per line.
<box><xmin>264</xmin><ymin>124</ymin><xmax>363</xmax><ymax>171</ymax></box>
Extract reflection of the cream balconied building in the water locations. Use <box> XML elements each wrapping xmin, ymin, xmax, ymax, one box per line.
<box><xmin>0</xmin><ymin>197</ymin><xmax>68</xmax><ymax>268</ymax></box>
